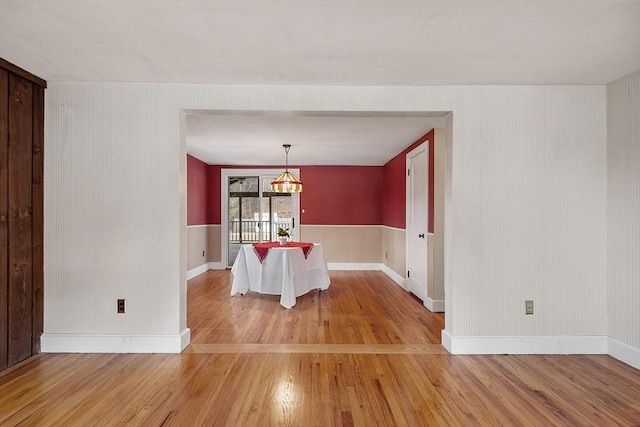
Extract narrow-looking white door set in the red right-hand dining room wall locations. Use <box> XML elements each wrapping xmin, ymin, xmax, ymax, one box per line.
<box><xmin>407</xmin><ymin>145</ymin><xmax>429</xmax><ymax>302</ymax></box>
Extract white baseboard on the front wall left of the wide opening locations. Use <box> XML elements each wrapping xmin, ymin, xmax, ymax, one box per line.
<box><xmin>40</xmin><ymin>328</ymin><xmax>191</xmax><ymax>353</ymax></box>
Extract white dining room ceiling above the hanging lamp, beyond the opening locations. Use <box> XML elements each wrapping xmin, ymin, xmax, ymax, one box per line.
<box><xmin>187</xmin><ymin>112</ymin><xmax>446</xmax><ymax>166</ymax></box>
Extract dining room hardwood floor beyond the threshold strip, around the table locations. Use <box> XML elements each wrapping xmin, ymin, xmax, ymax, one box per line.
<box><xmin>188</xmin><ymin>270</ymin><xmax>444</xmax><ymax>348</ymax></box>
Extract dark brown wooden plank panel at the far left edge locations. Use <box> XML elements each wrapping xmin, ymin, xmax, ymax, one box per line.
<box><xmin>0</xmin><ymin>58</ymin><xmax>46</xmax><ymax>370</ymax></box>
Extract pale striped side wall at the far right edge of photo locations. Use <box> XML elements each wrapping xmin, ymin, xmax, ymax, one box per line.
<box><xmin>607</xmin><ymin>72</ymin><xmax>640</xmax><ymax>360</ymax></box>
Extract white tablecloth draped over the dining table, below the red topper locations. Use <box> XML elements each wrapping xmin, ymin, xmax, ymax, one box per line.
<box><xmin>231</xmin><ymin>243</ymin><xmax>330</xmax><ymax>308</ymax></box>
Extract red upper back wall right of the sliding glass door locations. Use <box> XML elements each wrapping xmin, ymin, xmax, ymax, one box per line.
<box><xmin>300</xmin><ymin>166</ymin><xmax>382</xmax><ymax>225</ymax></box>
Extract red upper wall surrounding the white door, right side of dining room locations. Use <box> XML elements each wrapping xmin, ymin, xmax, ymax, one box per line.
<box><xmin>382</xmin><ymin>130</ymin><xmax>435</xmax><ymax>233</ymax></box>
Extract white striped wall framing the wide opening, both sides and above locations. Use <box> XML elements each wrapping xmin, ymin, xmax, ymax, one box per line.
<box><xmin>45</xmin><ymin>82</ymin><xmax>607</xmax><ymax>356</ymax></box>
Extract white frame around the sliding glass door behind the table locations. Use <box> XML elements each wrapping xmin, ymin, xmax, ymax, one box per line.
<box><xmin>220</xmin><ymin>168</ymin><xmax>300</xmax><ymax>268</ymax></box>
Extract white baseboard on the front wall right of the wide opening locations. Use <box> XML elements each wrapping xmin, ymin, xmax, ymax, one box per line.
<box><xmin>442</xmin><ymin>336</ymin><xmax>608</xmax><ymax>354</ymax></box>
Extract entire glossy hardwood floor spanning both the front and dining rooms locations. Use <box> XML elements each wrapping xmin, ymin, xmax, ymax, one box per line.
<box><xmin>0</xmin><ymin>272</ymin><xmax>640</xmax><ymax>426</ymax></box>
